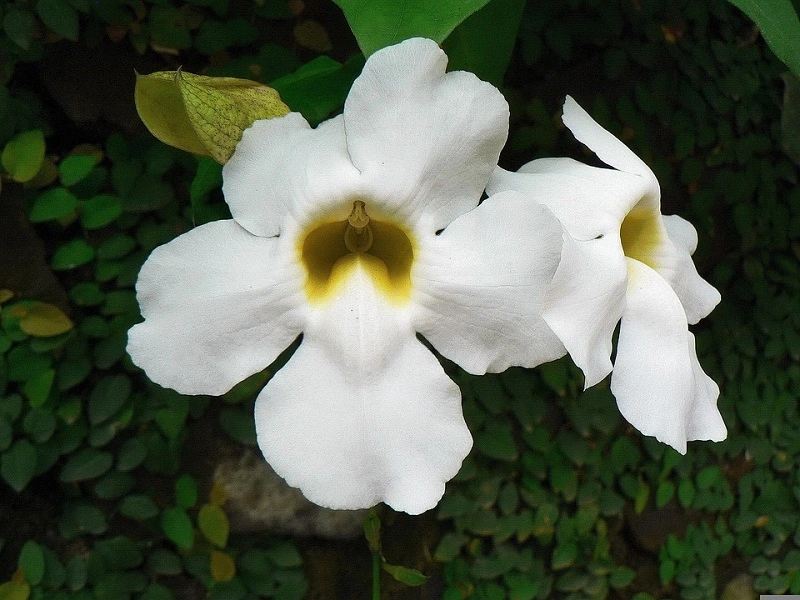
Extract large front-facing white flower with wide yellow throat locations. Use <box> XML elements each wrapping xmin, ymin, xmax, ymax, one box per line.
<box><xmin>128</xmin><ymin>39</ymin><xmax>565</xmax><ymax>513</ymax></box>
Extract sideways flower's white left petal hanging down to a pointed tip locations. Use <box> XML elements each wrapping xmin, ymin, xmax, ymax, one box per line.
<box><xmin>542</xmin><ymin>234</ymin><xmax>628</xmax><ymax>388</ymax></box>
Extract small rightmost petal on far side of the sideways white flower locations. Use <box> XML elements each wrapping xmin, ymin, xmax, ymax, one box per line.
<box><xmin>658</xmin><ymin>215</ymin><xmax>721</xmax><ymax>324</ymax></box>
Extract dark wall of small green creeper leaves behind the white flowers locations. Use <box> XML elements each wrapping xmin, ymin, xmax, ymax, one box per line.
<box><xmin>0</xmin><ymin>0</ymin><xmax>800</xmax><ymax>600</ymax></box>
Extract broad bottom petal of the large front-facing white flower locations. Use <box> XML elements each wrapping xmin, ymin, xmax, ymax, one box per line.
<box><xmin>256</xmin><ymin>260</ymin><xmax>472</xmax><ymax>514</ymax></box>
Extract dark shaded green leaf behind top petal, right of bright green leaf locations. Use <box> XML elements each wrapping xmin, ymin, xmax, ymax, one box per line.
<box><xmin>442</xmin><ymin>0</ymin><xmax>526</xmax><ymax>86</ymax></box>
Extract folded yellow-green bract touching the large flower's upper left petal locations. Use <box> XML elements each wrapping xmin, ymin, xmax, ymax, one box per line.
<box><xmin>135</xmin><ymin>71</ymin><xmax>289</xmax><ymax>164</ymax></box>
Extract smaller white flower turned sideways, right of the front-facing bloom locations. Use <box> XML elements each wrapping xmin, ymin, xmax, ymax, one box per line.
<box><xmin>487</xmin><ymin>97</ymin><xmax>727</xmax><ymax>453</ymax></box>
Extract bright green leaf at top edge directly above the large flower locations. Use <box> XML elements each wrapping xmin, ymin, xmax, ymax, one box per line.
<box><xmin>334</xmin><ymin>0</ymin><xmax>488</xmax><ymax>56</ymax></box>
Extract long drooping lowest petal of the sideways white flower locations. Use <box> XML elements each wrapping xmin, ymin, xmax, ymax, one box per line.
<box><xmin>611</xmin><ymin>259</ymin><xmax>726</xmax><ymax>454</ymax></box>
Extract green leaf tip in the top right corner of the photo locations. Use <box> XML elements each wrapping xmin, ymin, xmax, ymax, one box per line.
<box><xmin>729</xmin><ymin>0</ymin><xmax>800</xmax><ymax>75</ymax></box>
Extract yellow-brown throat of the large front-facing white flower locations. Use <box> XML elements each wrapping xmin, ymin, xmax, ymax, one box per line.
<box><xmin>299</xmin><ymin>200</ymin><xmax>414</xmax><ymax>304</ymax></box>
